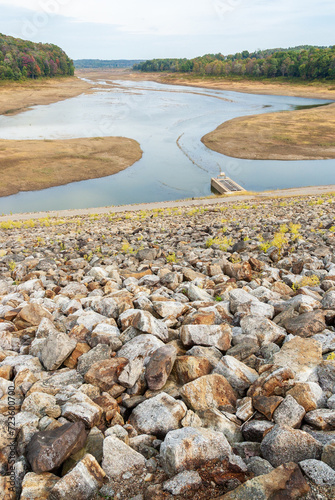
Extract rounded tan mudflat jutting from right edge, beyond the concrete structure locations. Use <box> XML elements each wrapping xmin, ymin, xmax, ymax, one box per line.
<box><xmin>202</xmin><ymin>104</ymin><xmax>335</xmax><ymax>160</ymax></box>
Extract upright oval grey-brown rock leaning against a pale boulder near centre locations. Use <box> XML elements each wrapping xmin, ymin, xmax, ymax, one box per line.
<box><xmin>145</xmin><ymin>345</ymin><xmax>177</xmax><ymax>391</ymax></box>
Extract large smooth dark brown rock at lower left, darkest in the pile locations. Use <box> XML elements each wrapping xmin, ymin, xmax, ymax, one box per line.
<box><xmin>27</xmin><ymin>422</ymin><xmax>87</xmax><ymax>474</ymax></box>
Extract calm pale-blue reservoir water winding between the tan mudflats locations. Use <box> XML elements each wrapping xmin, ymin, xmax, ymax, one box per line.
<box><xmin>0</xmin><ymin>77</ymin><xmax>335</xmax><ymax>213</ymax></box>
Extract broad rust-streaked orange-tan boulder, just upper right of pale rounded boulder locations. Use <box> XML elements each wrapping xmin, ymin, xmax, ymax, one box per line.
<box><xmin>180</xmin><ymin>374</ymin><xmax>236</xmax><ymax>411</ymax></box>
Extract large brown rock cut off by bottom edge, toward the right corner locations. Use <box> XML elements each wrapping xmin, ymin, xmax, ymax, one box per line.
<box><xmin>217</xmin><ymin>462</ymin><xmax>310</xmax><ymax>500</ymax></box>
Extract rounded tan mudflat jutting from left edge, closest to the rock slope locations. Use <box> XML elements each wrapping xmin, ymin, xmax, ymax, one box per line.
<box><xmin>0</xmin><ymin>137</ymin><xmax>142</xmax><ymax>196</ymax></box>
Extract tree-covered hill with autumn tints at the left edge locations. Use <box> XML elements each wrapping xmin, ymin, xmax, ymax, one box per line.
<box><xmin>0</xmin><ymin>33</ymin><xmax>74</xmax><ymax>80</ymax></box>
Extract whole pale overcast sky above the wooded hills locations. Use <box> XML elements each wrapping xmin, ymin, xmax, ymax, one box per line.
<box><xmin>0</xmin><ymin>0</ymin><xmax>335</xmax><ymax>59</ymax></box>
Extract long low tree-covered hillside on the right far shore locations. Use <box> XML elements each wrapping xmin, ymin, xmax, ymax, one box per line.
<box><xmin>134</xmin><ymin>45</ymin><xmax>335</xmax><ymax>80</ymax></box>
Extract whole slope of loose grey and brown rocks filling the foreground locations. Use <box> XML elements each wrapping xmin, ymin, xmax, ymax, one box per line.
<box><xmin>0</xmin><ymin>195</ymin><xmax>335</xmax><ymax>500</ymax></box>
